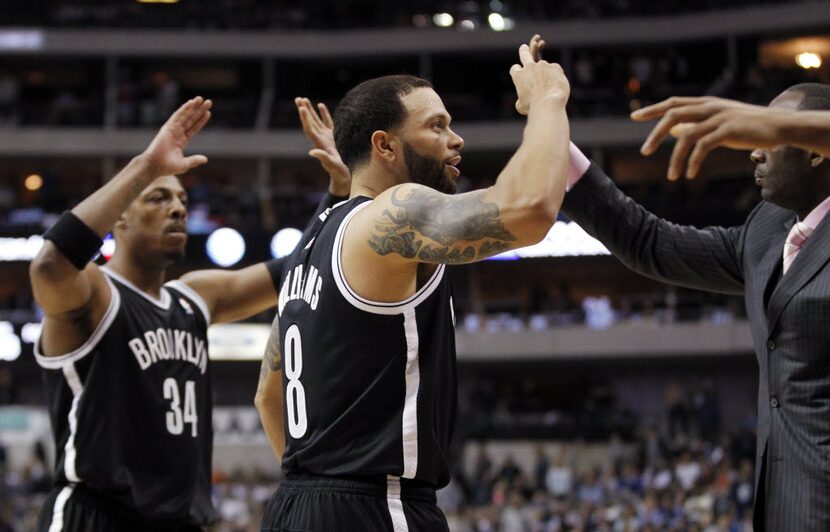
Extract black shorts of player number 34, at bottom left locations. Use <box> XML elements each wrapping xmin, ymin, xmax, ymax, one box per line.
<box><xmin>37</xmin><ymin>485</ymin><xmax>203</xmax><ymax>532</ymax></box>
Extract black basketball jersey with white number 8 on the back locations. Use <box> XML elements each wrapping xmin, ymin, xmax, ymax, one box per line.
<box><xmin>278</xmin><ymin>197</ymin><xmax>457</xmax><ymax>487</ymax></box>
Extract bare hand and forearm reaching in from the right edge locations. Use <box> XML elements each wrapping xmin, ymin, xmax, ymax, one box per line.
<box><xmin>631</xmin><ymin>96</ymin><xmax>830</xmax><ymax>180</ymax></box>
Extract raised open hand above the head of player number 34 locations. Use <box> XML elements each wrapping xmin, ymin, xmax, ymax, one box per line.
<box><xmin>142</xmin><ymin>96</ymin><xmax>213</xmax><ymax>177</ymax></box>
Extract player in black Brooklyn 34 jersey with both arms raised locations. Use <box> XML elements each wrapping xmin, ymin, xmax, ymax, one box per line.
<box><xmin>30</xmin><ymin>98</ymin><xmax>348</xmax><ymax>532</ymax></box>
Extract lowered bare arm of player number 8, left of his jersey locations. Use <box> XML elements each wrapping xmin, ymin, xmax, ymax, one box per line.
<box><xmin>254</xmin><ymin>316</ymin><xmax>285</xmax><ymax>461</ymax></box>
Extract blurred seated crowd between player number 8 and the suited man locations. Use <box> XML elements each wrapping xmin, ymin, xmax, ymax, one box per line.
<box><xmin>439</xmin><ymin>429</ymin><xmax>754</xmax><ymax>532</ymax></box>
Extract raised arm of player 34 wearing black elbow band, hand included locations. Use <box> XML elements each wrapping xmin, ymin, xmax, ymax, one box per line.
<box><xmin>29</xmin><ymin>97</ymin><xmax>211</xmax><ymax>354</ymax></box>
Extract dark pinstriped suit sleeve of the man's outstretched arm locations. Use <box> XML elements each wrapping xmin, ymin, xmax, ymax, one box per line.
<box><xmin>562</xmin><ymin>164</ymin><xmax>744</xmax><ymax>294</ymax></box>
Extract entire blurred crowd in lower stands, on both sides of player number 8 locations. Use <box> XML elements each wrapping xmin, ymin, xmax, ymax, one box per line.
<box><xmin>0</xmin><ymin>376</ymin><xmax>755</xmax><ymax>532</ymax></box>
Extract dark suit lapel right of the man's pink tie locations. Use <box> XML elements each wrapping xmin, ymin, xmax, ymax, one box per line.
<box><xmin>767</xmin><ymin>213</ymin><xmax>830</xmax><ymax>331</ymax></box>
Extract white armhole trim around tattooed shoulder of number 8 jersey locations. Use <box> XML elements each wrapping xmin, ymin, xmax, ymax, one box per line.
<box><xmin>331</xmin><ymin>201</ymin><xmax>446</xmax><ymax>315</ymax></box>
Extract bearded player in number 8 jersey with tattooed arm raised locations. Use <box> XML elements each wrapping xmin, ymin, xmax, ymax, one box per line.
<box><xmin>262</xmin><ymin>36</ymin><xmax>569</xmax><ymax>532</ymax></box>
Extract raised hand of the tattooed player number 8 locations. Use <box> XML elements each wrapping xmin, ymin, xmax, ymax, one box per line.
<box><xmin>510</xmin><ymin>35</ymin><xmax>571</xmax><ymax>115</ymax></box>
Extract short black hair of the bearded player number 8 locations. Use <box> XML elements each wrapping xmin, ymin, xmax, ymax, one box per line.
<box><xmin>334</xmin><ymin>75</ymin><xmax>432</xmax><ymax>172</ymax></box>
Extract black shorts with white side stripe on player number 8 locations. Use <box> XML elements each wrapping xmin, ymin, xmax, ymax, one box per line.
<box><xmin>262</xmin><ymin>475</ymin><xmax>449</xmax><ymax>532</ymax></box>
